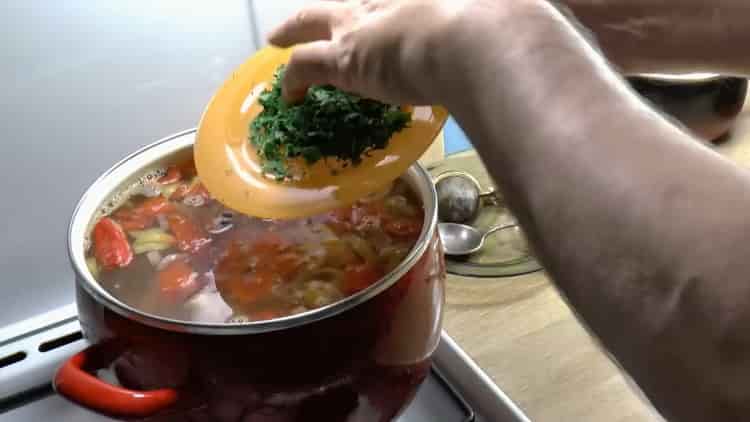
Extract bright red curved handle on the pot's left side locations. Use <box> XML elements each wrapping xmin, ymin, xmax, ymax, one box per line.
<box><xmin>52</xmin><ymin>345</ymin><xmax>178</xmax><ymax>417</ymax></box>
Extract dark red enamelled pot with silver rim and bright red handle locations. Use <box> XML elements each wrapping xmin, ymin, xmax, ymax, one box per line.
<box><xmin>54</xmin><ymin>131</ymin><xmax>445</xmax><ymax>422</ymax></box>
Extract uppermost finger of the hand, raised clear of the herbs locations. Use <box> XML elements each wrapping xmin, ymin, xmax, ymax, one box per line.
<box><xmin>268</xmin><ymin>1</ymin><xmax>348</xmax><ymax>47</ymax></box>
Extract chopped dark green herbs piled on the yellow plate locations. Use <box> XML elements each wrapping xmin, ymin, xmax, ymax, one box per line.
<box><xmin>250</xmin><ymin>66</ymin><xmax>411</xmax><ymax>180</ymax></box>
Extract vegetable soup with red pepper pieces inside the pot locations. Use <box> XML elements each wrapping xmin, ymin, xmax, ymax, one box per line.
<box><xmin>87</xmin><ymin>162</ymin><xmax>424</xmax><ymax>323</ymax></box>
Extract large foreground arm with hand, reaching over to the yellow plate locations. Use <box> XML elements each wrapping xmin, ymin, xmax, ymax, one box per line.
<box><xmin>271</xmin><ymin>0</ymin><xmax>750</xmax><ymax>421</ymax></box>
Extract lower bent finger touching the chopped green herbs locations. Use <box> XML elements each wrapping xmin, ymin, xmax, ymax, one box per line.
<box><xmin>281</xmin><ymin>41</ymin><xmax>337</xmax><ymax>103</ymax></box>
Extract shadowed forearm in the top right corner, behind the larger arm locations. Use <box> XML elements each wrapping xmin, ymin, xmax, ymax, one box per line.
<box><xmin>559</xmin><ymin>0</ymin><xmax>750</xmax><ymax>76</ymax></box>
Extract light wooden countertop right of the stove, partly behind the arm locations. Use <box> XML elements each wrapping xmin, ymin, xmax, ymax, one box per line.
<box><xmin>445</xmin><ymin>101</ymin><xmax>750</xmax><ymax>422</ymax></box>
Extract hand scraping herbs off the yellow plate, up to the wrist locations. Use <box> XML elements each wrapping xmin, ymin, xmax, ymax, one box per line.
<box><xmin>269</xmin><ymin>0</ymin><xmax>538</xmax><ymax>104</ymax></box>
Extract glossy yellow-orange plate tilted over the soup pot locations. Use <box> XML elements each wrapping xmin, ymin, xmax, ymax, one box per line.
<box><xmin>194</xmin><ymin>47</ymin><xmax>448</xmax><ymax>218</ymax></box>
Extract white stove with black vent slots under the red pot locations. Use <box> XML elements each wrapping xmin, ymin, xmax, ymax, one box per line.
<box><xmin>0</xmin><ymin>303</ymin><xmax>528</xmax><ymax>422</ymax></box>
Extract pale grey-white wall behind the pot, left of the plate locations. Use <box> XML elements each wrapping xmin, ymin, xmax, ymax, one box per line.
<box><xmin>0</xmin><ymin>0</ymin><xmax>316</xmax><ymax>326</ymax></box>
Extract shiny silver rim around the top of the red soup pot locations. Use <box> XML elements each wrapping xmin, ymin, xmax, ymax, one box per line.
<box><xmin>68</xmin><ymin>129</ymin><xmax>437</xmax><ymax>335</ymax></box>
